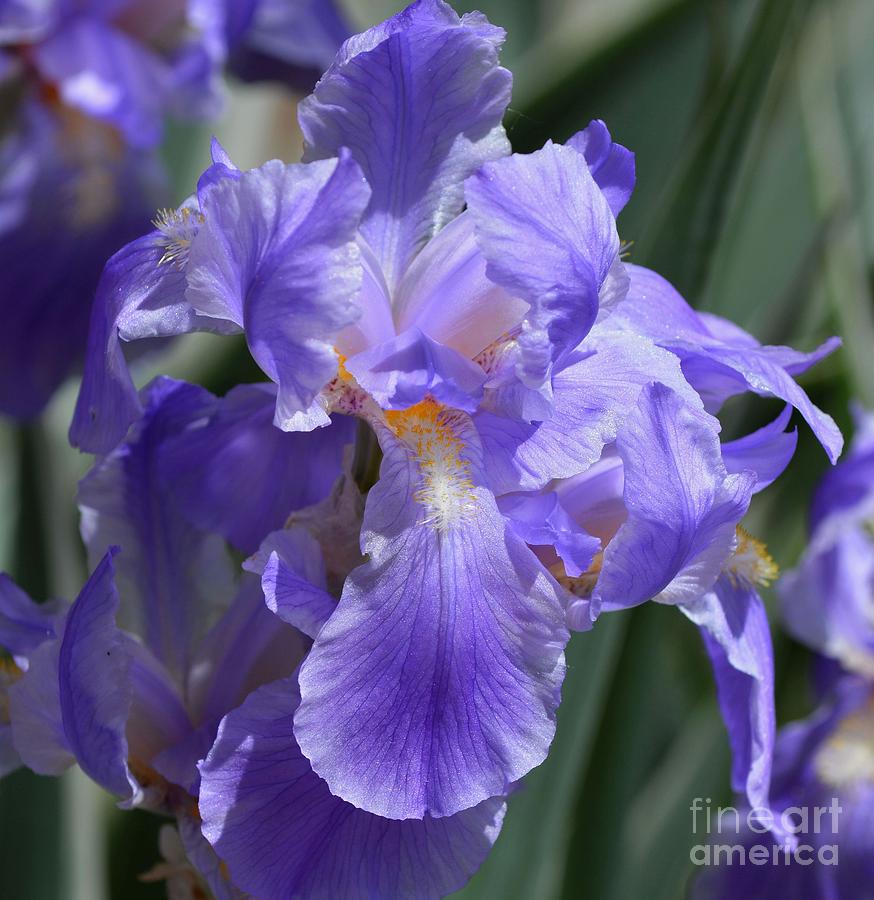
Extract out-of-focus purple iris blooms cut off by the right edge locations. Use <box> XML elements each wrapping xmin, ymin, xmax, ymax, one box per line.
<box><xmin>695</xmin><ymin>409</ymin><xmax>874</xmax><ymax>900</ymax></box>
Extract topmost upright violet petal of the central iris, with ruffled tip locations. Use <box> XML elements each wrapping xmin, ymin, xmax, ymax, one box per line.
<box><xmin>298</xmin><ymin>0</ymin><xmax>511</xmax><ymax>291</ymax></box>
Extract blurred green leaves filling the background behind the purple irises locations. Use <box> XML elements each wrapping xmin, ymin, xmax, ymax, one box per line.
<box><xmin>0</xmin><ymin>0</ymin><xmax>874</xmax><ymax>900</ymax></box>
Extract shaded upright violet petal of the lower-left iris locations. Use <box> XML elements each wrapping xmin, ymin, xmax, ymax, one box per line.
<box><xmin>78</xmin><ymin>378</ymin><xmax>233</xmax><ymax>679</ymax></box>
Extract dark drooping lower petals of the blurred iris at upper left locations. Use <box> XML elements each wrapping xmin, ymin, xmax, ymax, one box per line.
<box><xmin>0</xmin><ymin>102</ymin><xmax>167</xmax><ymax>419</ymax></box>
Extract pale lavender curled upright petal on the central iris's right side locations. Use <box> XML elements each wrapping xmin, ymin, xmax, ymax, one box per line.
<box><xmin>465</xmin><ymin>143</ymin><xmax>619</xmax><ymax>387</ymax></box>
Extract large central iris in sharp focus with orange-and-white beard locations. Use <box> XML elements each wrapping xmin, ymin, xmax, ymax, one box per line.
<box><xmin>72</xmin><ymin>2</ymin><xmax>604</xmax><ymax>819</ymax></box>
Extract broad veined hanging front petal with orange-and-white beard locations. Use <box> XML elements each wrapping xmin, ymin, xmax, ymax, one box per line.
<box><xmin>295</xmin><ymin>401</ymin><xmax>568</xmax><ymax>819</ymax></box>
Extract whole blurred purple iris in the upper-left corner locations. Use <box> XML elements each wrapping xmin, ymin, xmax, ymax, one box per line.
<box><xmin>0</xmin><ymin>0</ymin><xmax>347</xmax><ymax>419</ymax></box>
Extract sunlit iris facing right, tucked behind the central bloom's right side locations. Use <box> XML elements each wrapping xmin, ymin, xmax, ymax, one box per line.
<box><xmin>490</xmin><ymin>378</ymin><xmax>795</xmax><ymax>828</ymax></box>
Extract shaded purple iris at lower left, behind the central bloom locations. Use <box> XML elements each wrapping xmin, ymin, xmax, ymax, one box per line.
<box><xmin>0</xmin><ymin>370</ymin><xmax>322</xmax><ymax>772</ymax></box>
